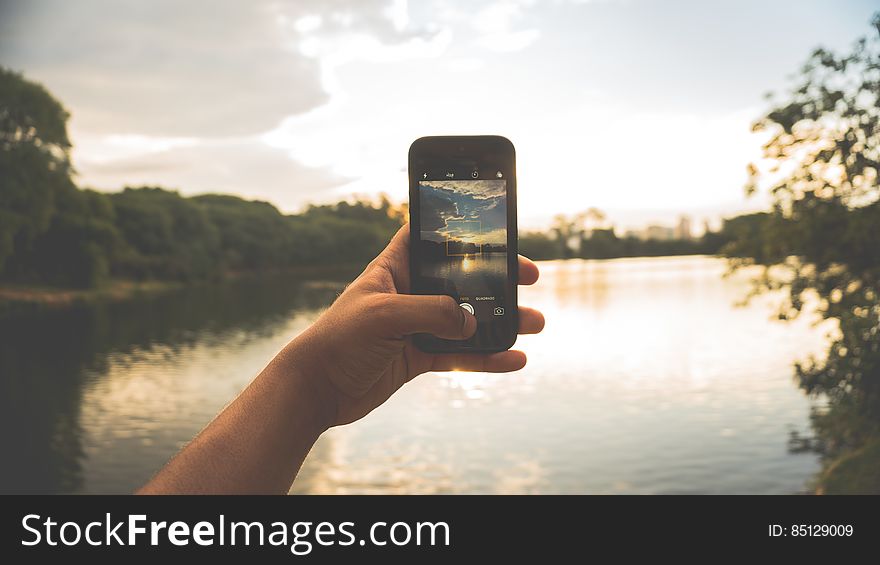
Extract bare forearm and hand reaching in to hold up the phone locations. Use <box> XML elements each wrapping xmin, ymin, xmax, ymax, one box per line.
<box><xmin>139</xmin><ymin>226</ymin><xmax>544</xmax><ymax>494</ymax></box>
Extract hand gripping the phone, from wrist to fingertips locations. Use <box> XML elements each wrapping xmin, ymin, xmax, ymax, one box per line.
<box><xmin>288</xmin><ymin>224</ymin><xmax>544</xmax><ymax>427</ymax></box>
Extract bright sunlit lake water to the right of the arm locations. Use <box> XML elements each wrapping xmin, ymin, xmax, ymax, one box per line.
<box><xmin>294</xmin><ymin>258</ymin><xmax>825</xmax><ymax>493</ymax></box>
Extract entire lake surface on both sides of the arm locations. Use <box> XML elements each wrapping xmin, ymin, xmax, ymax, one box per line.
<box><xmin>0</xmin><ymin>257</ymin><xmax>827</xmax><ymax>493</ymax></box>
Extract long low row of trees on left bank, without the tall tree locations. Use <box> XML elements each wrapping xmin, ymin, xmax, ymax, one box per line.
<box><xmin>0</xmin><ymin>182</ymin><xmax>402</xmax><ymax>288</ymax></box>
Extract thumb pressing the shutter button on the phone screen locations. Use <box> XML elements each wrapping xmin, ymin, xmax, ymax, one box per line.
<box><xmin>380</xmin><ymin>294</ymin><xmax>477</xmax><ymax>339</ymax></box>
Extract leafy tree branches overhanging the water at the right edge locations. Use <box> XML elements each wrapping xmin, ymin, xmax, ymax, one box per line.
<box><xmin>727</xmin><ymin>14</ymin><xmax>880</xmax><ymax>485</ymax></box>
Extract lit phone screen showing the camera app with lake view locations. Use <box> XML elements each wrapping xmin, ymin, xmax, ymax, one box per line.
<box><xmin>419</xmin><ymin>172</ymin><xmax>507</xmax><ymax>322</ymax></box>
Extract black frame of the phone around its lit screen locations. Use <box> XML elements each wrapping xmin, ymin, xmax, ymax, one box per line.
<box><xmin>408</xmin><ymin>135</ymin><xmax>519</xmax><ymax>353</ymax></box>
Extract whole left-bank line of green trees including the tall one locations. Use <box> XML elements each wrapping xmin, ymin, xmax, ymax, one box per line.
<box><xmin>0</xmin><ymin>67</ymin><xmax>404</xmax><ymax>288</ymax></box>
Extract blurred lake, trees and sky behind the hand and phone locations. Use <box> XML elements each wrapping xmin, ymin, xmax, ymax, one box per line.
<box><xmin>0</xmin><ymin>0</ymin><xmax>880</xmax><ymax>493</ymax></box>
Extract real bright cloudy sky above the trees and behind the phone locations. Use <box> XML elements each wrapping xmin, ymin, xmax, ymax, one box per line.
<box><xmin>0</xmin><ymin>0</ymin><xmax>876</xmax><ymax>229</ymax></box>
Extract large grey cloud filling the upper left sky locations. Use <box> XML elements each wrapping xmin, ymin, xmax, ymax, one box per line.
<box><xmin>0</xmin><ymin>0</ymin><xmax>433</xmax><ymax>209</ymax></box>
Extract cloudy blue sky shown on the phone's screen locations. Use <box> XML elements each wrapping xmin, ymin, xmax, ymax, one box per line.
<box><xmin>419</xmin><ymin>179</ymin><xmax>507</xmax><ymax>245</ymax></box>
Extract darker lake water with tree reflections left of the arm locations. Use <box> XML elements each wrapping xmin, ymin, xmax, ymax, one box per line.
<box><xmin>0</xmin><ymin>278</ymin><xmax>341</xmax><ymax>492</ymax></box>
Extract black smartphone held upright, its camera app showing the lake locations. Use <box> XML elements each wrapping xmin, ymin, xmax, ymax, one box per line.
<box><xmin>409</xmin><ymin>135</ymin><xmax>519</xmax><ymax>353</ymax></box>
